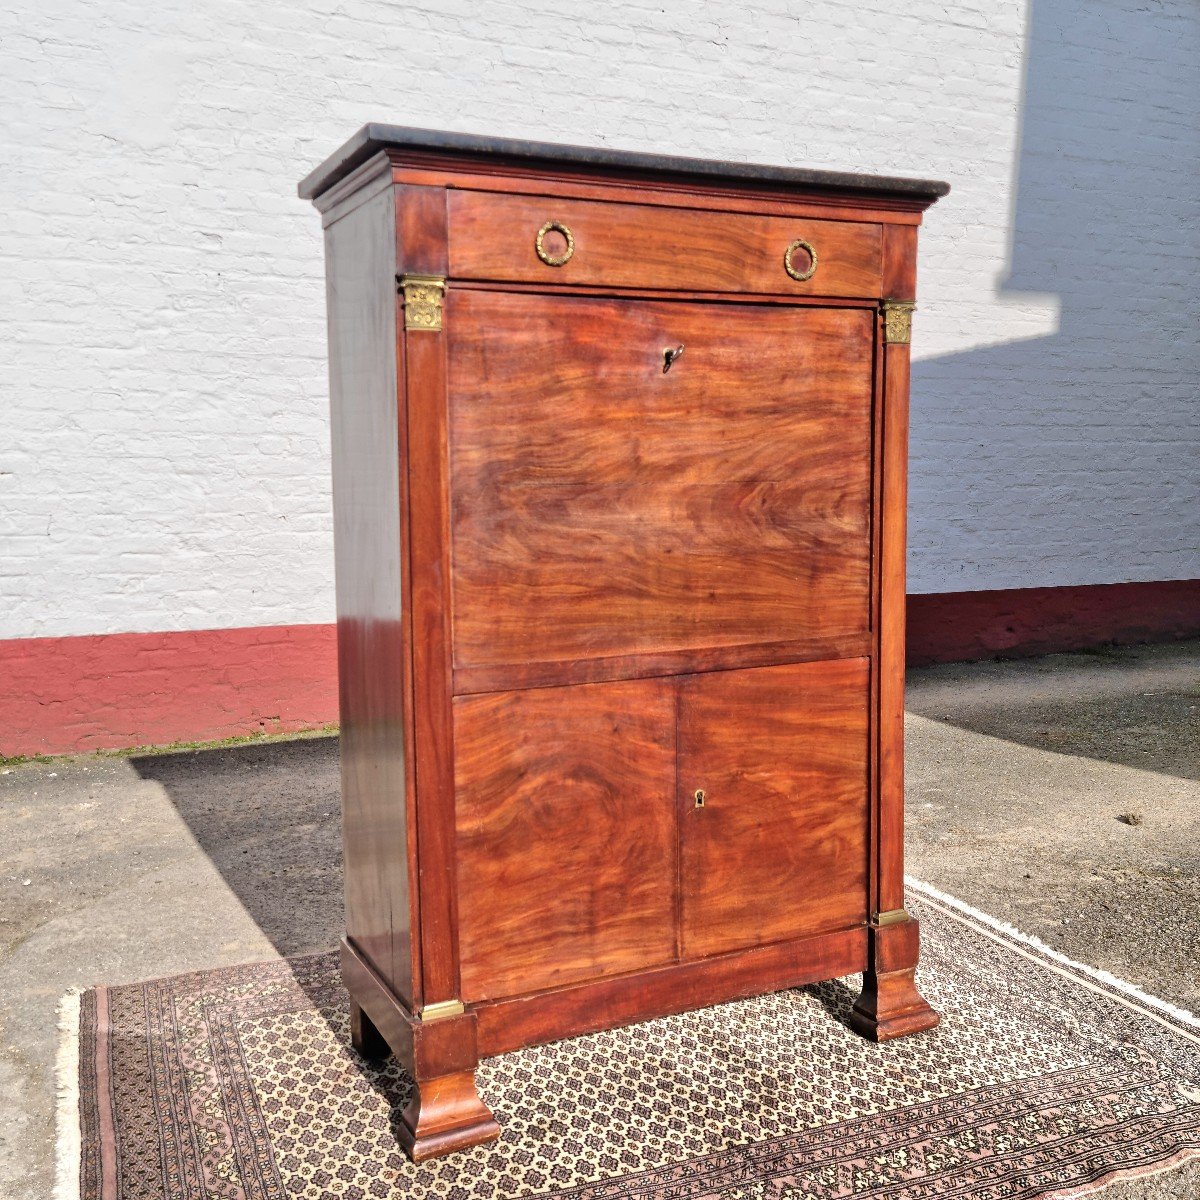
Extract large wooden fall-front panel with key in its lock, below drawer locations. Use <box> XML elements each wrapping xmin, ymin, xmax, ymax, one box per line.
<box><xmin>446</xmin><ymin>289</ymin><xmax>872</xmax><ymax>667</ymax></box>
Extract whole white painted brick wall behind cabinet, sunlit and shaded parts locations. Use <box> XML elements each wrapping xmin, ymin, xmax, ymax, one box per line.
<box><xmin>0</xmin><ymin>0</ymin><xmax>1200</xmax><ymax>637</ymax></box>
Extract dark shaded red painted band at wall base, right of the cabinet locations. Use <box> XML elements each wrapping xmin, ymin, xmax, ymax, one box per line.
<box><xmin>907</xmin><ymin>580</ymin><xmax>1200</xmax><ymax>666</ymax></box>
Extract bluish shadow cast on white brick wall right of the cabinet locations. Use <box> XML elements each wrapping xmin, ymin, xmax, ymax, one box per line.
<box><xmin>910</xmin><ymin>0</ymin><xmax>1200</xmax><ymax>592</ymax></box>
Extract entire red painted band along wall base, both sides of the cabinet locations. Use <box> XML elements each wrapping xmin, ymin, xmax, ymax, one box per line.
<box><xmin>0</xmin><ymin>580</ymin><xmax>1200</xmax><ymax>757</ymax></box>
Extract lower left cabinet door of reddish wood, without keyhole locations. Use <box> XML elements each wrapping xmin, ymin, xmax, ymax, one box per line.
<box><xmin>455</xmin><ymin>680</ymin><xmax>678</xmax><ymax>1002</ymax></box>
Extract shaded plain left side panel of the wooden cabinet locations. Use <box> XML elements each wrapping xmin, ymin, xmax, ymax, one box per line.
<box><xmin>325</xmin><ymin>190</ymin><xmax>413</xmax><ymax>1000</ymax></box>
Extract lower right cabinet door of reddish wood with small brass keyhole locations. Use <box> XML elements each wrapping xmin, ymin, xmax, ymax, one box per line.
<box><xmin>678</xmin><ymin>659</ymin><xmax>869</xmax><ymax>959</ymax></box>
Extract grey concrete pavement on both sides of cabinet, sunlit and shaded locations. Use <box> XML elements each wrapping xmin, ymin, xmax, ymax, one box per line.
<box><xmin>0</xmin><ymin>642</ymin><xmax>1200</xmax><ymax>1200</ymax></box>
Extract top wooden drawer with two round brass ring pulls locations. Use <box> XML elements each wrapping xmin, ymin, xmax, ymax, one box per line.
<box><xmin>448</xmin><ymin>191</ymin><xmax>882</xmax><ymax>298</ymax></box>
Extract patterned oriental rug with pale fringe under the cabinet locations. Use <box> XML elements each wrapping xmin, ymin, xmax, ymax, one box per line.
<box><xmin>59</xmin><ymin>881</ymin><xmax>1200</xmax><ymax>1200</ymax></box>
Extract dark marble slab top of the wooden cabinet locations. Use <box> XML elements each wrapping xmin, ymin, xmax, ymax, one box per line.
<box><xmin>298</xmin><ymin>124</ymin><xmax>950</xmax><ymax>203</ymax></box>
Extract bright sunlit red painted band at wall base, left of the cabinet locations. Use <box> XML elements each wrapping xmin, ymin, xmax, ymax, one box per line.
<box><xmin>0</xmin><ymin>625</ymin><xmax>337</xmax><ymax>757</ymax></box>
